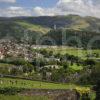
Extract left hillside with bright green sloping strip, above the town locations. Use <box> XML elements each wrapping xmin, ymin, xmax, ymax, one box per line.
<box><xmin>0</xmin><ymin>19</ymin><xmax>50</xmax><ymax>42</ymax></box>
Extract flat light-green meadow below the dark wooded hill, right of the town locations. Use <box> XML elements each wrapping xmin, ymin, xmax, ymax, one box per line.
<box><xmin>36</xmin><ymin>46</ymin><xmax>100</xmax><ymax>59</ymax></box>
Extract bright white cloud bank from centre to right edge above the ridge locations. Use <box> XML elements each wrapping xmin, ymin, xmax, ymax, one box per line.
<box><xmin>33</xmin><ymin>0</ymin><xmax>100</xmax><ymax>17</ymax></box>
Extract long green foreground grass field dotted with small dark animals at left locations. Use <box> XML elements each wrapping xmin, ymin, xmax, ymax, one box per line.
<box><xmin>0</xmin><ymin>78</ymin><xmax>89</xmax><ymax>89</ymax></box>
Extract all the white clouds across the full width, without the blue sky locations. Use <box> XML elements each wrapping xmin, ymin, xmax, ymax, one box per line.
<box><xmin>0</xmin><ymin>0</ymin><xmax>100</xmax><ymax>18</ymax></box>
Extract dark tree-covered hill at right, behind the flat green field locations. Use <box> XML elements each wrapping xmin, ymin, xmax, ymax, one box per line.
<box><xmin>44</xmin><ymin>29</ymin><xmax>100</xmax><ymax>49</ymax></box>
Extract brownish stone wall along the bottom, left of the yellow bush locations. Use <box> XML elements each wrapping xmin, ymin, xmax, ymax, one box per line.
<box><xmin>20</xmin><ymin>89</ymin><xmax>80</xmax><ymax>100</ymax></box>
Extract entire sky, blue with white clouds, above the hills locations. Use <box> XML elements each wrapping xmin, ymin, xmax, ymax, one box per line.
<box><xmin>0</xmin><ymin>0</ymin><xmax>100</xmax><ymax>18</ymax></box>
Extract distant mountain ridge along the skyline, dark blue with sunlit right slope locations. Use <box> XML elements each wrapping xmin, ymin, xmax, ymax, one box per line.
<box><xmin>0</xmin><ymin>15</ymin><xmax>100</xmax><ymax>32</ymax></box>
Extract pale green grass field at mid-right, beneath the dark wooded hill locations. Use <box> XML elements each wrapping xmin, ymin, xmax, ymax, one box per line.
<box><xmin>36</xmin><ymin>46</ymin><xmax>100</xmax><ymax>59</ymax></box>
